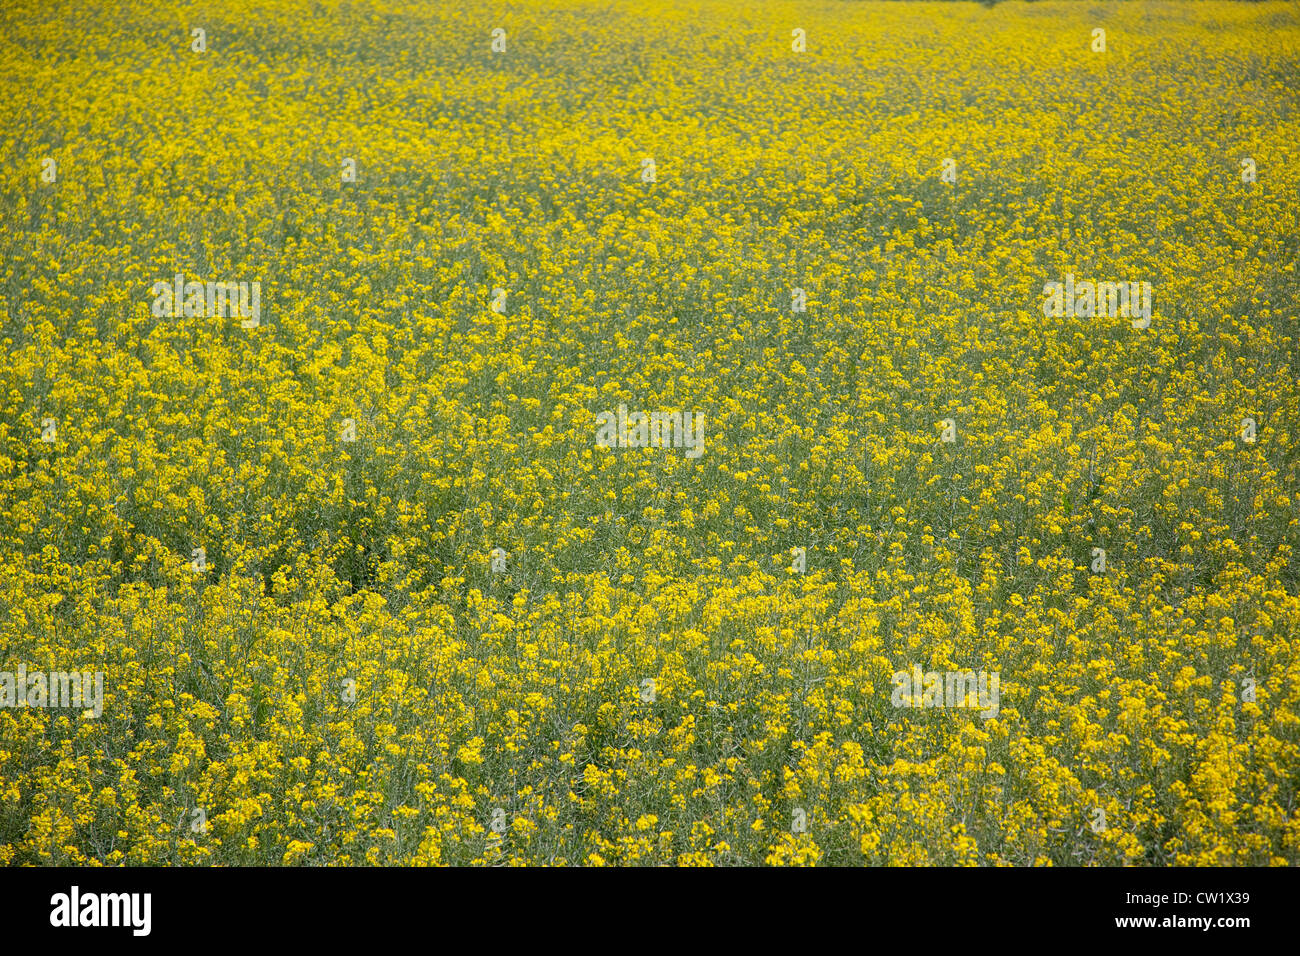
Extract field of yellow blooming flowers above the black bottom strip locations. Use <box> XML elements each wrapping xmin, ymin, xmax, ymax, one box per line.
<box><xmin>0</xmin><ymin>0</ymin><xmax>1300</xmax><ymax>866</ymax></box>
